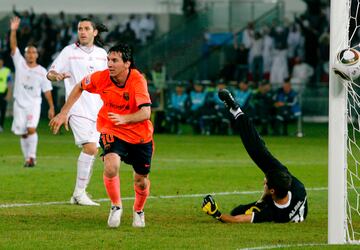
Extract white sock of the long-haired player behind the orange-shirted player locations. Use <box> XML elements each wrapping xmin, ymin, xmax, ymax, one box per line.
<box><xmin>74</xmin><ymin>152</ymin><xmax>95</xmax><ymax>196</ymax></box>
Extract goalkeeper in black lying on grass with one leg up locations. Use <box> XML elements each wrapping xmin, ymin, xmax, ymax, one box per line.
<box><xmin>202</xmin><ymin>89</ymin><xmax>308</xmax><ymax>223</ymax></box>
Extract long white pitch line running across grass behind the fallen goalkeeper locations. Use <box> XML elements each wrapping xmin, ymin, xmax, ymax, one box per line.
<box><xmin>0</xmin><ymin>187</ymin><xmax>327</xmax><ymax>208</ymax></box>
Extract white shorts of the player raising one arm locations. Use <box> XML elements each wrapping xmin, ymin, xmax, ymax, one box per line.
<box><xmin>11</xmin><ymin>101</ymin><xmax>41</xmax><ymax>135</ymax></box>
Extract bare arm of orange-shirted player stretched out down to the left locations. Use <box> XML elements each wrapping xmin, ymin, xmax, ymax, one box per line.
<box><xmin>49</xmin><ymin>83</ymin><xmax>82</xmax><ymax>134</ymax></box>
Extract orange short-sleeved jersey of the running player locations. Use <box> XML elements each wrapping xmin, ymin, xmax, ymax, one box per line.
<box><xmin>81</xmin><ymin>69</ymin><xmax>154</xmax><ymax>144</ymax></box>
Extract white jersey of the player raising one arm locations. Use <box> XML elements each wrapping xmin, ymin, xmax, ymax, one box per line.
<box><xmin>12</xmin><ymin>48</ymin><xmax>52</xmax><ymax>108</ymax></box>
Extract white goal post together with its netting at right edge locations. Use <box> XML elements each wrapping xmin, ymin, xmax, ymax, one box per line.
<box><xmin>328</xmin><ymin>0</ymin><xmax>360</xmax><ymax>244</ymax></box>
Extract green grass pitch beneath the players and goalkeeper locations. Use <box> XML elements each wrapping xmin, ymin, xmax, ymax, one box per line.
<box><xmin>0</xmin><ymin>121</ymin><xmax>355</xmax><ymax>249</ymax></box>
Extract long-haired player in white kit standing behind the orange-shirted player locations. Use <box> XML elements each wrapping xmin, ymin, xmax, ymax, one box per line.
<box><xmin>47</xmin><ymin>18</ymin><xmax>107</xmax><ymax>206</ymax></box>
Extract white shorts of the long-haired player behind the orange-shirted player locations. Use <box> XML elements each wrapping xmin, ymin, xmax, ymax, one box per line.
<box><xmin>69</xmin><ymin>115</ymin><xmax>100</xmax><ymax>147</ymax></box>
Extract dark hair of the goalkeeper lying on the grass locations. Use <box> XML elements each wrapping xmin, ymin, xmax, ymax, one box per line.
<box><xmin>265</xmin><ymin>170</ymin><xmax>292</xmax><ymax>199</ymax></box>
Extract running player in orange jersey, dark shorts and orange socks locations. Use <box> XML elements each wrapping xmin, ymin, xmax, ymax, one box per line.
<box><xmin>49</xmin><ymin>44</ymin><xmax>153</xmax><ymax>227</ymax></box>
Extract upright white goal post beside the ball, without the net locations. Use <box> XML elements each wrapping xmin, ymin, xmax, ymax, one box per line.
<box><xmin>328</xmin><ymin>0</ymin><xmax>351</xmax><ymax>244</ymax></box>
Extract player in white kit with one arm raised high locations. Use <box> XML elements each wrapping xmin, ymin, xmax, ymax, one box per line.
<box><xmin>10</xmin><ymin>17</ymin><xmax>55</xmax><ymax>167</ymax></box>
